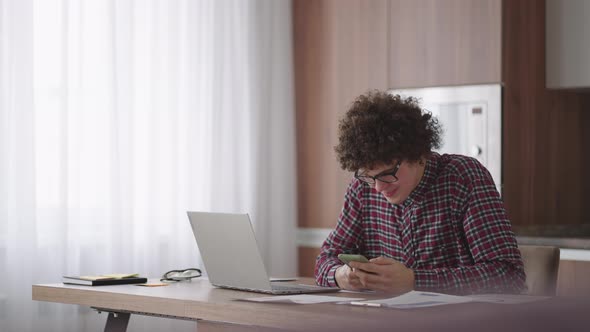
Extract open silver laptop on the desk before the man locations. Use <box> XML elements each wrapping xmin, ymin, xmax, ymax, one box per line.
<box><xmin>187</xmin><ymin>211</ymin><xmax>339</xmax><ymax>294</ymax></box>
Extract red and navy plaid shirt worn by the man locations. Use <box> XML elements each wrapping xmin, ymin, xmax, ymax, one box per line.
<box><xmin>315</xmin><ymin>153</ymin><xmax>526</xmax><ymax>294</ymax></box>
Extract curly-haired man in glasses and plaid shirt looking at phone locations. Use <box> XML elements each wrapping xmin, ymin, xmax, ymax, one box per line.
<box><xmin>315</xmin><ymin>91</ymin><xmax>526</xmax><ymax>294</ymax></box>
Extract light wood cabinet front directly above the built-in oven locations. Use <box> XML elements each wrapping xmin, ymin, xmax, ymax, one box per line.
<box><xmin>389</xmin><ymin>0</ymin><xmax>501</xmax><ymax>88</ymax></box>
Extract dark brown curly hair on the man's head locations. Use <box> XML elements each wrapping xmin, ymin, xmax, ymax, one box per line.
<box><xmin>334</xmin><ymin>90</ymin><xmax>442</xmax><ymax>172</ymax></box>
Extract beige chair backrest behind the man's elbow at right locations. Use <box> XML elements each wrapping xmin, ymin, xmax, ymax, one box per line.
<box><xmin>518</xmin><ymin>245</ymin><xmax>559</xmax><ymax>296</ymax></box>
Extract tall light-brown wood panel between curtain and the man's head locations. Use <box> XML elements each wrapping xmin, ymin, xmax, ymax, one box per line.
<box><xmin>293</xmin><ymin>0</ymin><xmax>388</xmax><ymax>228</ymax></box>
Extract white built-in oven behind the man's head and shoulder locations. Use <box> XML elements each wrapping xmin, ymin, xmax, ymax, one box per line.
<box><xmin>390</xmin><ymin>84</ymin><xmax>502</xmax><ymax>193</ymax></box>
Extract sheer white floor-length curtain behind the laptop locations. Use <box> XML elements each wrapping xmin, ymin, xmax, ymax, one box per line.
<box><xmin>0</xmin><ymin>0</ymin><xmax>297</xmax><ymax>331</ymax></box>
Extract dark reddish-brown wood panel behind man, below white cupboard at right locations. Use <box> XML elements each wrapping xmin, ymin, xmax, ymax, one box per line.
<box><xmin>502</xmin><ymin>0</ymin><xmax>590</xmax><ymax>236</ymax></box>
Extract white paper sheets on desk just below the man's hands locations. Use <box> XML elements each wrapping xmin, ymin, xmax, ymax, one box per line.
<box><xmin>350</xmin><ymin>291</ymin><xmax>473</xmax><ymax>309</ymax></box>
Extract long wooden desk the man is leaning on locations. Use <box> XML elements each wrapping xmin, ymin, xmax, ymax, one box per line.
<box><xmin>33</xmin><ymin>279</ymin><xmax>590</xmax><ymax>332</ymax></box>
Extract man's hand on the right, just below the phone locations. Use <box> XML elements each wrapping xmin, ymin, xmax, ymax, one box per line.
<box><xmin>352</xmin><ymin>257</ymin><xmax>414</xmax><ymax>293</ymax></box>
